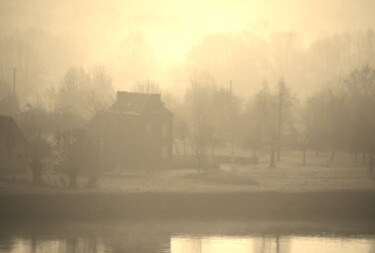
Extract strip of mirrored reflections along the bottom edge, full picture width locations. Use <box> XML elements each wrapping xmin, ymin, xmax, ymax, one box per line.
<box><xmin>0</xmin><ymin>235</ymin><xmax>375</xmax><ymax>253</ymax></box>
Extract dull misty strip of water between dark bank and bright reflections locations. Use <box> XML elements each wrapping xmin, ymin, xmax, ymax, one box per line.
<box><xmin>0</xmin><ymin>219</ymin><xmax>375</xmax><ymax>238</ymax></box>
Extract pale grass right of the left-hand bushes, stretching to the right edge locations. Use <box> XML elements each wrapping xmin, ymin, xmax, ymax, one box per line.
<box><xmin>100</xmin><ymin>152</ymin><xmax>375</xmax><ymax>192</ymax></box>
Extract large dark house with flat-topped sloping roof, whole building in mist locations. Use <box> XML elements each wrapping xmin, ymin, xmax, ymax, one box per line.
<box><xmin>88</xmin><ymin>91</ymin><xmax>173</xmax><ymax>169</ymax></box>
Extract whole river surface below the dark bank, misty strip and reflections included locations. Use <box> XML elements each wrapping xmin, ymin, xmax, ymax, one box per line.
<box><xmin>0</xmin><ymin>221</ymin><xmax>375</xmax><ymax>253</ymax></box>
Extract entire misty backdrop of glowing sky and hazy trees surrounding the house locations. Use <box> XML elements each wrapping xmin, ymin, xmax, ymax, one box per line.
<box><xmin>0</xmin><ymin>0</ymin><xmax>375</xmax><ymax>186</ymax></box>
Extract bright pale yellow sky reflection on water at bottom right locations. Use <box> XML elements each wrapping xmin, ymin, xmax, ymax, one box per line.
<box><xmin>171</xmin><ymin>236</ymin><xmax>375</xmax><ymax>253</ymax></box>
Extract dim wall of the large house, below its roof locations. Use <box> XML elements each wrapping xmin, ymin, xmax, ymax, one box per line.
<box><xmin>89</xmin><ymin>113</ymin><xmax>173</xmax><ymax>170</ymax></box>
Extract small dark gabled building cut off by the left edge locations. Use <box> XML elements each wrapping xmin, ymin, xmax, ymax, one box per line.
<box><xmin>0</xmin><ymin>116</ymin><xmax>28</xmax><ymax>172</ymax></box>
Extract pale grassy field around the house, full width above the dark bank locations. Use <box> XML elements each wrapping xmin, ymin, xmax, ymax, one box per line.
<box><xmin>0</xmin><ymin>151</ymin><xmax>375</xmax><ymax>193</ymax></box>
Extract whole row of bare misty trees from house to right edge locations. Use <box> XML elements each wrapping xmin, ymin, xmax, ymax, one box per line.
<box><xmin>175</xmin><ymin>66</ymin><xmax>375</xmax><ymax>170</ymax></box>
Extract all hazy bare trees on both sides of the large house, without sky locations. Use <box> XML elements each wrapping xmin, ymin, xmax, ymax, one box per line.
<box><xmin>0</xmin><ymin>30</ymin><xmax>375</xmax><ymax>187</ymax></box>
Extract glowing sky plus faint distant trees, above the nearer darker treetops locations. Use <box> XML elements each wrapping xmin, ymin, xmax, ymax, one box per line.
<box><xmin>0</xmin><ymin>0</ymin><xmax>375</xmax><ymax>104</ymax></box>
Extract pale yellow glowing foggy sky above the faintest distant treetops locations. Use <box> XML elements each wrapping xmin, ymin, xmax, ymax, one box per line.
<box><xmin>0</xmin><ymin>0</ymin><xmax>375</xmax><ymax>95</ymax></box>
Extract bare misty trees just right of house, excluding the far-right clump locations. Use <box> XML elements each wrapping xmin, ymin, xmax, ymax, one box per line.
<box><xmin>175</xmin><ymin>73</ymin><xmax>295</xmax><ymax>171</ymax></box>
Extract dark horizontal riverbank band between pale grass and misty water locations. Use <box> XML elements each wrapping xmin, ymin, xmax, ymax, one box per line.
<box><xmin>0</xmin><ymin>191</ymin><xmax>375</xmax><ymax>221</ymax></box>
